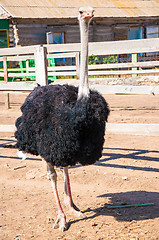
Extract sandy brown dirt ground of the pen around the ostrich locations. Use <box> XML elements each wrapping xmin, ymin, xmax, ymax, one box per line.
<box><xmin>0</xmin><ymin>93</ymin><xmax>159</xmax><ymax>240</ymax></box>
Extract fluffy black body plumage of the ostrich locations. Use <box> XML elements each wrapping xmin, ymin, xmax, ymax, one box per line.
<box><xmin>15</xmin><ymin>85</ymin><xmax>109</xmax><ymax>167</ymax></box>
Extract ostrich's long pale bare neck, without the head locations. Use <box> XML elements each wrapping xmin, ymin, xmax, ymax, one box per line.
<box><xmin>78</xmin><ymin>20</ymin><xmax>89</xmax><ymax>99</ymax></box>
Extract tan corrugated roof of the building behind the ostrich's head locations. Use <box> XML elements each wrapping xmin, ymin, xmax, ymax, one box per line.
<box><xmin>0</xmin><ymin>0</ymin><xmax>159</xmax><ymax>18</ymax></box>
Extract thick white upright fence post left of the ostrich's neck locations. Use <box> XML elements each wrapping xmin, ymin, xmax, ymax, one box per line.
<box><xmin>34</xmin><ymin>46</ymin><xmax>48</xmax><ymax>86</ymax></box>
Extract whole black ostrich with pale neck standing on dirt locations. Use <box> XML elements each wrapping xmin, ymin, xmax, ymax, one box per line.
<box><xmin>15</xmin><ymin>7</ymin><xmax>109</xmax><ymax>231</ymax></box>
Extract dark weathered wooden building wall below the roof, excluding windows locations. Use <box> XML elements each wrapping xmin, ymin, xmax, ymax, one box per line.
<box><xmin>9</xmin><ymin>18</ymin><xmax>159</xmax><ymax>46</ymax></box>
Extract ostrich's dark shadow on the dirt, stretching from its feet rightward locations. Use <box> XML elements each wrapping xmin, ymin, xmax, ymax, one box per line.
<box><xmin>70</xmin><ymin>191</ymin><xmax>159</xmax><ymax>228</ymax></box>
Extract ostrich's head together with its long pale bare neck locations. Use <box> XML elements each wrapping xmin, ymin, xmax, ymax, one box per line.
<box><xmin>78</xmin><ymin>7</ymin><xmax>94</xmax><ymax>99</ymax></box>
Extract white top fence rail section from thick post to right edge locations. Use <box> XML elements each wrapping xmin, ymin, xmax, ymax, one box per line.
<box><xmin>44</xmin><ymin>38</ymin><xmax>159</xmax><ymax>55</ymax></box>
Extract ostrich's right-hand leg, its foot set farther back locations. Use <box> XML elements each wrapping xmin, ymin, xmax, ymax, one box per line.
<box><xmin>64</xmin><ymin>167</ymin><xmax>84</xmax><ymax>217</ymax></box>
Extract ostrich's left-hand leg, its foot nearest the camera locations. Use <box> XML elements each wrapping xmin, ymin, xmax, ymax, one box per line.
<box><xmin>47</xmin><ymin>163</ymin><xmax>68</xmax><ymax>232</ymax></box>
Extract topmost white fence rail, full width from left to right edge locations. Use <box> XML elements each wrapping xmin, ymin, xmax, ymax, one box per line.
<box><xmin>0</xmin><ymin>38</ymin><xmax>159</xmax><ymax>56</ymax></box>
